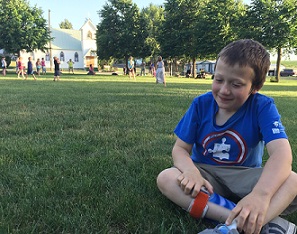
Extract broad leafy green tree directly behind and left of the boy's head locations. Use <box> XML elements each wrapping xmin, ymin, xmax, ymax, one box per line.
<box><xmin>160</xmin><ymin>0</ymin><xmax>245</xmax><ymax>76</ymax></box>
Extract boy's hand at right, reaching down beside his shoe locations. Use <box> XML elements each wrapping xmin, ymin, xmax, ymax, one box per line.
<box><xmin>226</xmin><ymin>193</ymin><xmax>270</xmax><ymax>234</ymax></box>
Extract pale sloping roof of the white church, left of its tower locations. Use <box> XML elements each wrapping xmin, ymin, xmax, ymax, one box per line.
<box><xmin>51</xmin><ymin>28</ymin><xmax>82</xmax><ymax>51</ymax></box>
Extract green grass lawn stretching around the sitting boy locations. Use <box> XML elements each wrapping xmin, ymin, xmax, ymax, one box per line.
<box><xmin>0</xmin><ymin>74</ymin><xmax>297</xmax><ymax>234</ymax></box>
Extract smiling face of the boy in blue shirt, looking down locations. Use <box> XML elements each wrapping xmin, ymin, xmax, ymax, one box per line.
<box><xmin>212</xmin><ymin>58</ymin><xmax>254</xmax><ymax>114</ymax></box>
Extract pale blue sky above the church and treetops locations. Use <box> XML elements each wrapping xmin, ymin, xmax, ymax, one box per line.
<box><xmin>28</xmin><ymin>0</ymin><xmax>250</xmax><ymax>30</ymax></box>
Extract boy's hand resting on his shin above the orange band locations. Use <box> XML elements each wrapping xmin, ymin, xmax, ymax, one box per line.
<box><xmin>177</xmin><ymin>171</ymin><xmax>213</xmax><ymax>197</ymax></box>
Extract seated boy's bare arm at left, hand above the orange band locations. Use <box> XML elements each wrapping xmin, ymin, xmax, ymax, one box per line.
<box><xmin>172</xmin><ymin>138</ymin><xmax>213</xmax><ymax>197</ymax></box>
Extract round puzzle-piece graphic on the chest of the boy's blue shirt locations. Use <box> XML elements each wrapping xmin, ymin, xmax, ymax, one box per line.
<box><xmin>203</xmin><ymin>130</ymin><xmax>247</xmax><ymax>164</ymax></box>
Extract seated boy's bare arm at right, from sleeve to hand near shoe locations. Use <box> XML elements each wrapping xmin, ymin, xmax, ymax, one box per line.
<box><xmin>226</xmin><ymin>139</ymin><xmax>292</xmax><ymax>233</ymax></box>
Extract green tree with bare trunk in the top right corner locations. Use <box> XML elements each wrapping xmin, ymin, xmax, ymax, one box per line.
<box><xmin>238</xmin><ymin>0</ymin><xmax>297</xmax><ymax>82</ymax></box>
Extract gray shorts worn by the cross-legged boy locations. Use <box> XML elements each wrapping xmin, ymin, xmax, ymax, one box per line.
<box><xmin>195</xmin><ymin>163</ymin><xmax>297</xmax><ymax>215</ymax></box>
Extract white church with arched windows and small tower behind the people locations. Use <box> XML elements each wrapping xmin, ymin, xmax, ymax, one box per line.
<box><xmin>20</xmin><ymin>19</ymin><xmax>98</xmax><ymax>70</ymax></box>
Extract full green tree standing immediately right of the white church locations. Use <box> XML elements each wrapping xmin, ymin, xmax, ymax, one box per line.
<box><xmin>96</xmin><ymin>0</ymin><xmax>147</xmax><ymax>65</ymax></box>
